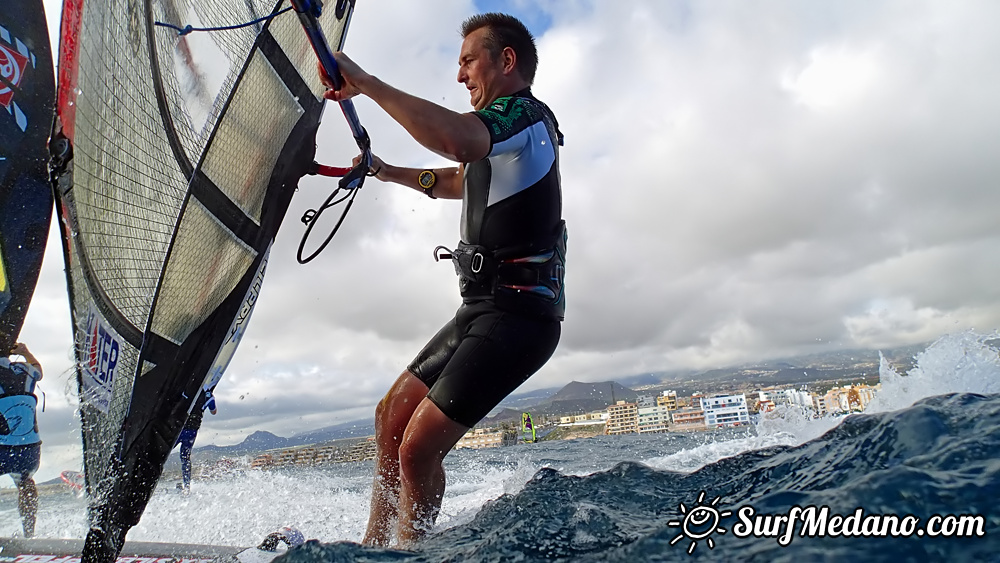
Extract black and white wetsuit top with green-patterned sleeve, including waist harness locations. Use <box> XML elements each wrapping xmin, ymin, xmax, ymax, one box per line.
<box><xmin>461</xmin><ymin>89</ymin><xmax>565</xmax><ymax>320</ymax></box>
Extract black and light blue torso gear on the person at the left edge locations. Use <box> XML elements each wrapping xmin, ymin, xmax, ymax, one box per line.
<box><xmin>0</xmin><ymin>358</ymin><xmax>42</xmax><ymax>447</ymax></box>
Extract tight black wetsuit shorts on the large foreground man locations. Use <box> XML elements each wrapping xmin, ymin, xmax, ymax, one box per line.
<box><xmin>408</xmin><ymin>300</ymin><xmax>562</xmax><ymax>428</ymax></box>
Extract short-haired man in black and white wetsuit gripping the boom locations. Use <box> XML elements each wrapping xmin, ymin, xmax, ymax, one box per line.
<box><xmin>320</xmin><ymin>13</ymin><xmax>566</xmax><ymax>547</ymax></box>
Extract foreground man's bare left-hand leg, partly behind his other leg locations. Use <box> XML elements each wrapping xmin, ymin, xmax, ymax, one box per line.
<box><xmin>362</xmin><ymin>371</ymin><xmax>428</xmax><ymax>546</ymax></box>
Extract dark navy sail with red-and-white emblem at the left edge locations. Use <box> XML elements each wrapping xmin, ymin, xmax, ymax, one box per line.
<box><xmin>0</xmin><ymin>0</ymin><xmax>55</xmax><ymax>354</ymax></box>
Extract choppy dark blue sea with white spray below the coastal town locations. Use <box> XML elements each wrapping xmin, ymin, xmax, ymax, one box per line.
<box><xmin>0</xmin><ymin>332</ymin><xmax>1000</xmax><ymax>563</ymax></box>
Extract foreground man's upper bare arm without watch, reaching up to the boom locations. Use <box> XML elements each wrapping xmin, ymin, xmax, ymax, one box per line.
<box><xmin>320</xmin><ymin>52</ymin><xmax>490</xmax><ymax>164</ymax></box>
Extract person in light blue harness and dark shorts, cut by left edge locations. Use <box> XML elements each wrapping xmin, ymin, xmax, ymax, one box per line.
<box><xmin>0</xmin><ymin>342</ymin><xmax>42</xmax><ymax>538</ymax></box>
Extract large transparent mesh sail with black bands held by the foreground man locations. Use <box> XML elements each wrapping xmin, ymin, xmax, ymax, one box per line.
<box><xmin>52</xmin><ymin>0</ymin><xmax>354</xmax><ymax>561</ymax></box>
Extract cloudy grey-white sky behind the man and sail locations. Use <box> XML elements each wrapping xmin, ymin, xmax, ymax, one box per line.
<box><xmin>22</xmin><ymin>0</ymin><xmax>1000</xmax><ymax>479</ymax></box>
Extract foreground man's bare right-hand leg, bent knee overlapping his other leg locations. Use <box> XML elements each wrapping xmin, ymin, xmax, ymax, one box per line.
<box><xmin>396</xmin><ymin>399</ymin><xmax>469</xmax><ymax>548</ymax></box>
